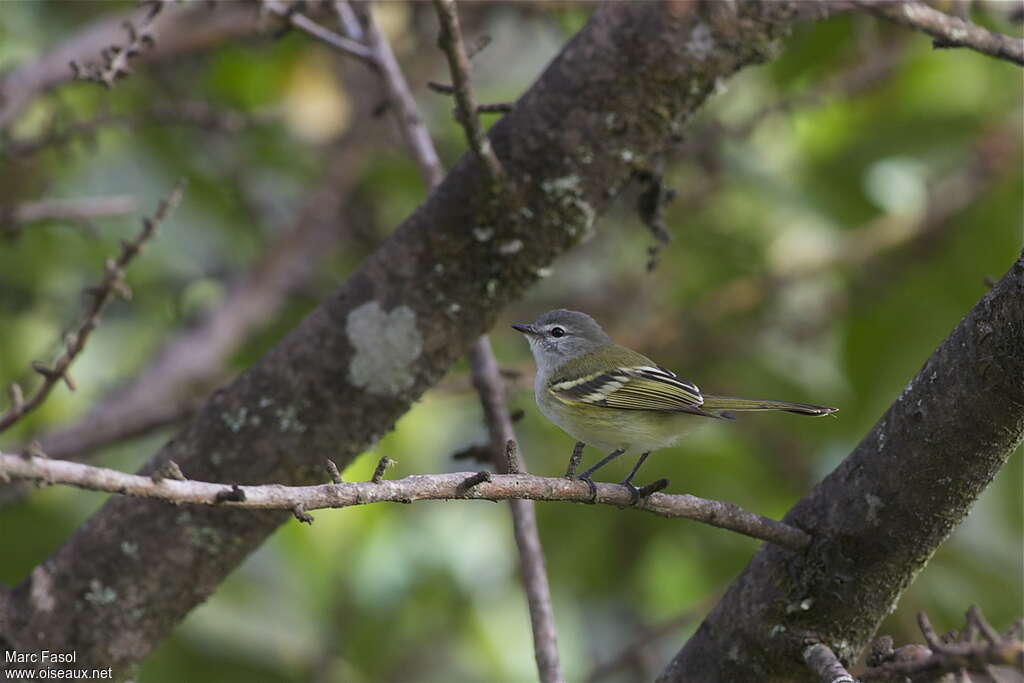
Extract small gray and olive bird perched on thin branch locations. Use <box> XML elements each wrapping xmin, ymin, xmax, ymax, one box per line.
<box><xmin>512</xmin><ymin>308</ymin><xmax>837</xmax><ymax>505</ymax></box>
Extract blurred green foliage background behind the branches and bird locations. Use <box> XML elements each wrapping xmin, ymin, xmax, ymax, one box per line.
<box><xmin>0</xmin><ymin>2</ymin><xmax>1024</xmax><ymax>682</ymax></box>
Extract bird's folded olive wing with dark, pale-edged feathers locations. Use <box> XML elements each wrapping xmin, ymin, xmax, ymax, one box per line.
<box><xmin>548</xmin><ymin>347</ymin><xmax>715</xmax><ymax>417</ymax></box>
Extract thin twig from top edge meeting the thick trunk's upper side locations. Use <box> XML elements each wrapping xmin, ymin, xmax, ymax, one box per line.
<box><xmin>434</xmin><ymin>0</ymin><xmax>505</xmax><ymax>183</ymax></box>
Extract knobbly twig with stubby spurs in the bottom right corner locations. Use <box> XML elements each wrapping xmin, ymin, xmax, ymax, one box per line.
<box><xmin>860</xmin><ymin>606</ymin><xmax>1024</xmax><ymax>682</ymax></box>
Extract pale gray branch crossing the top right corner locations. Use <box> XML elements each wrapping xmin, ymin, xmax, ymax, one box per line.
<box><xmin>853</xmin><ymin>0</ymin><xmax>1024</xmax><ymax>66</ymax></box>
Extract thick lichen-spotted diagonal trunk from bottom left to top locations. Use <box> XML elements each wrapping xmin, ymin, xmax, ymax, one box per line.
<box><xmin>0</xmin><ymin>2</ymin><xmax>827</xmax><ymax>677</ymax></box>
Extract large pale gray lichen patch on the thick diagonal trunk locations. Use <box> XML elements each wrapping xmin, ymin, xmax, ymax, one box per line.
<box><xmin>345</xmin><ymin>301</ymin><xmax>423</xmax><ymax>396</ymax></box>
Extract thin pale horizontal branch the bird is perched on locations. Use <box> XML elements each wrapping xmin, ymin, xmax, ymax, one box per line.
<box><xmin>0</xmin><ymin>453</ymin><xmax>811</xmax><ymax>550</ymax></box>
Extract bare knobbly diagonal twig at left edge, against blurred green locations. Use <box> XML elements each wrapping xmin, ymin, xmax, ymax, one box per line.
<box><xmin>0</xmin><ymin>181</ymin><xmax>184</xmax><ymax>432</ymax></box>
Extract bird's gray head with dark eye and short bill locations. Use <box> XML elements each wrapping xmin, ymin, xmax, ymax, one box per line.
<box><xmin>512</xmin><ymin>308</ymin><xmax>611</xmax><ymax>374</ymax></box>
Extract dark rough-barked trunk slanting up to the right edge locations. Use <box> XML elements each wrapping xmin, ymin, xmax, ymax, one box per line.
<box><xmin>658</xmin><ymin>254</ymin><xmax>1024</xmax><ymax>683</ymax></box>
